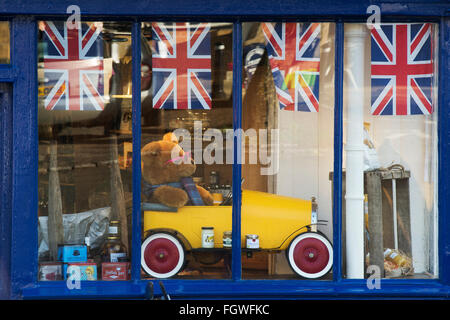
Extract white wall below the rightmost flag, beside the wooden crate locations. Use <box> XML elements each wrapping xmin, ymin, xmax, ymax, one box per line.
<box><xmin>366</xmin><ymin>115</ymin><xmax>436</xmax><ymax>272</ymax></box>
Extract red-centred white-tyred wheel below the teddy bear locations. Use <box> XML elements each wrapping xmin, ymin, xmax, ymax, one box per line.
<box><xmin>141</xmin><ymin>233</ymin><xmax>185</xmax><ymax>278</ymax></box>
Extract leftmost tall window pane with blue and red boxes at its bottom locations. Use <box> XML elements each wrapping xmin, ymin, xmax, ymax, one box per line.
<box><xmin>38</xmin><ymin>21</ymin><xmax>132</xmax><ymax>283</ymax></box>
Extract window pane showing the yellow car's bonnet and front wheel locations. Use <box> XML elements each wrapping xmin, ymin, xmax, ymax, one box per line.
<box><xmin>242</xmin><ymin>22</ymin><xmax>335</xmax><ymax>279</ymax></box>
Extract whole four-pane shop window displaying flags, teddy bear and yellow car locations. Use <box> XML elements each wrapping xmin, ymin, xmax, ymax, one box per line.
<box><xmin>33</xmin><ymin>16</ymin><xmax>438</xmax><ymax>281</ymax></box>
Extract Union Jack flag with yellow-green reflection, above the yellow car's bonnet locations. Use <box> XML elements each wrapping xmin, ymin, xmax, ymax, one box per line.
<box><xmin>262</xmin><ymin>23</ymin><xmax>320</xmax><ymax>112</ymax></box>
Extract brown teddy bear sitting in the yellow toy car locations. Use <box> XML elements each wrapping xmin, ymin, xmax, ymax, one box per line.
<box><xmin>141</xmin><ymin>132</ymin><xmax>214</xmax><ymax>208</ymax></box>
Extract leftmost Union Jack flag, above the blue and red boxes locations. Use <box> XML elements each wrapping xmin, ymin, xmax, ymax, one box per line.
<box><xmin>41</xmin><ymin>21</ymin><xmax>104</xmax><ymax>110</ymax></box>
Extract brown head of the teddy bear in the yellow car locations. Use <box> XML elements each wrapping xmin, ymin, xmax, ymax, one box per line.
<box><xmin>141</xmin><ymin>139</ymin><xmax>196</xmax><ymax>185</ymax></box>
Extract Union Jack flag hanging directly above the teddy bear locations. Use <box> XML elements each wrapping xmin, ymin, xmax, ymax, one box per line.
<box><xmin>152</xmin><ymin>23</ymin><xmax>212</xmax><ymax>109</ymax></box>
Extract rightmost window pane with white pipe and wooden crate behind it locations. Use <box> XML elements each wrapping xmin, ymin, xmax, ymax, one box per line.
<box><xmin>342</xmin><ymin>23</ymin><xmax>438</xmax><ymax>278</ymax></box>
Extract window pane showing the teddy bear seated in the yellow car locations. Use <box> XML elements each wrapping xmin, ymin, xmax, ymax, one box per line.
<box><xmin>141</xmin><ymin>22</ymin><xmax>233</xmax><ymax>279</ymax></box>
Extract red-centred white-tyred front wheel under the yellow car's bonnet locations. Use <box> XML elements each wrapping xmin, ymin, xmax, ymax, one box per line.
<box><xmin>286</xmin><ymin>232</ymin><xmax>333</xmax><ymax>279</ymax></box>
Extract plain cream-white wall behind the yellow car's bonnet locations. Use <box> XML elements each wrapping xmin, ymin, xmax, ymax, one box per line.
<box><xmin>276</xmin><ymin>24</ymin><xmax>334</xmax><ymax>241</ymax></box>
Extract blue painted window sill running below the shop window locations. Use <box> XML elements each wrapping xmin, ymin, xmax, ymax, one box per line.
<box><xmin>22</xmin><ymin>280</ymin><xmax>450</xmax><ymax>299</ymax></box>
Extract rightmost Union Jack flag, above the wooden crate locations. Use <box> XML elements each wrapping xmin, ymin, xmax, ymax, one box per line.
<box><xmin>371</xmin><ymin>23</ymin><xmax>434</xmax><ymax>115</ymax></box>
